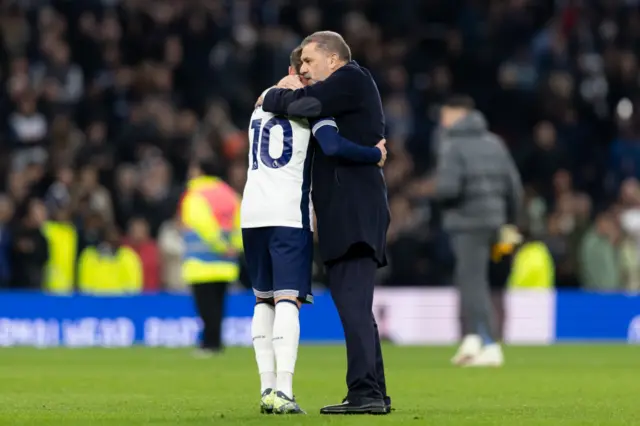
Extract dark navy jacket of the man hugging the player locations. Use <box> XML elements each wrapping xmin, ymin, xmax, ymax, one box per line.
<box><xmin>262</xmin><ymin>61</ymin><xmax>390</xmax><ymax>266</ymax></box>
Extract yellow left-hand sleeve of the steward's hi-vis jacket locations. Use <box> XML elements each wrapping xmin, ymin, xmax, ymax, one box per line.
<box><xmin>182</xmin><ymin>193</ymin><xmax>231</xmax><ymax>254</ymax></box>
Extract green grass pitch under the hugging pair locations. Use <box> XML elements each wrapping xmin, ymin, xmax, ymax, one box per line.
<box><xmin>0</xmin><ymin>346</ymin><xmax>640</xmax><ymax>426</ymax></box>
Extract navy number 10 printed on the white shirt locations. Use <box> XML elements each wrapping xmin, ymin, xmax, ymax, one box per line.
<box><xmin>251</xmin><ymin>117</ymin><xmax>293</xmax><ymax>170</ymax></box>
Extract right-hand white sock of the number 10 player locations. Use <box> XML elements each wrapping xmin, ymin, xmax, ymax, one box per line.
<box><xmin>273</xmin><ymin>302</ymin><xmax>300</xmax><ymax>398</ymax></box>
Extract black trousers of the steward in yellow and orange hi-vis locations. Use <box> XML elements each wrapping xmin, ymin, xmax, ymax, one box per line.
<box><xmin>191</xmin><ymin>282</ymin><xmax>229</xmax><ymax>351</ymax></box>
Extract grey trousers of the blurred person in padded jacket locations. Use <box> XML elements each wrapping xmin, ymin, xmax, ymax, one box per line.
<box><xmin>451</xmin><ymin>230</ymin><xmax>497</xmax><ymax>340</ymax></box>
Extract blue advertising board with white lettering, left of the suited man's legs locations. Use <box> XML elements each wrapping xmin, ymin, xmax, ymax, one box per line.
<box><xmin>0</xmin><ymin>293</ymin><xmax>344</xmax><ymax>347</ymax></box>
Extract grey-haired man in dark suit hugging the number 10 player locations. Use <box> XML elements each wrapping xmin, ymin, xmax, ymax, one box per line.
<box><xmin>262</xmin><ymin>31</ymin><xmax>391</xmax><ymax>414</ymax></box>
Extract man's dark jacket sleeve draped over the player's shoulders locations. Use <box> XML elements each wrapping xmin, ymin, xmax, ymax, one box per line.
<box><xmin>262</xmin><ymin>65</ymin><xmax>362</xmax><ymax>118</ymax></box>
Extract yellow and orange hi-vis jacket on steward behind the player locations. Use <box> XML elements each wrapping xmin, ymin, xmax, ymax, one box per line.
<box><xmin>180</xmin><ymin>176</ymin><xmax>242</xmax><ymax>284</ymax></box>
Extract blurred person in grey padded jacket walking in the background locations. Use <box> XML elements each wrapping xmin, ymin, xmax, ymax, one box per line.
<box><xmin>434</xmin><ymin>96</ymin><xmax>522</xmax><ymax>366</ymax></box>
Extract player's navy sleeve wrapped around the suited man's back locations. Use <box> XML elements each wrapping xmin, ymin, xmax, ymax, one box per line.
<box><xmin>310</xmin><ymin>118</ymin><xmax>382</xmax><ymax>164</ymax></box>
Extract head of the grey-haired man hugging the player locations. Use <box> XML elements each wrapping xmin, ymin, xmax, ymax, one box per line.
<box><xmin>300</xmin><ymin>31</ymin><xmax>351</xmax><ymax>81</ymax></box>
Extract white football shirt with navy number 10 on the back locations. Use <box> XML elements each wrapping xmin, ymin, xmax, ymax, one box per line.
<box><xmin>241</xmin><ymin>107</ymin><xmax>313</xmax><ymax>230</ymax></box>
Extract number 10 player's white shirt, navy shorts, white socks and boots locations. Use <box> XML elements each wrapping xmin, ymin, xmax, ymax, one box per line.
<box><xmin>245</xmin><ymin>92</ymin><xmax>313</xmax><ymax>413</ymax></box>
